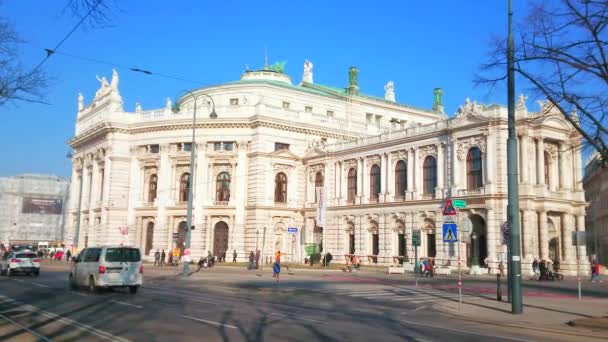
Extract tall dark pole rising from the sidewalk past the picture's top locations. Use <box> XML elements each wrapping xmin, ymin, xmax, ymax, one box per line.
<box><xmin>507</xmin><ymin>0</ymin><xmax>523</xmax><ymax>314</ymax></box>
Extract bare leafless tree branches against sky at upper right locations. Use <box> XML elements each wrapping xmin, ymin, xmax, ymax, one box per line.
<box><xmin>476</xmin><ymin>0</ymin><xmax>608</xmax><ymax>163</ymax></box>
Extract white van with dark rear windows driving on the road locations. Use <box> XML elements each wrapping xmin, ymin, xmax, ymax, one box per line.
<box><xmin>69</xmin><ymin>246</ymin><xmax>144</xmax><ymax>294</ymax></box>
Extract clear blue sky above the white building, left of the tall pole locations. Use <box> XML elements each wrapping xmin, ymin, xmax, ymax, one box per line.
<box><xmin>0</xmin><ymin>0</ymin><xmax>531</xmax><ymax>176</ymax></box>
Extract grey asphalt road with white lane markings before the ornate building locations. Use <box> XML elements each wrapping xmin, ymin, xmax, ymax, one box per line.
<box><xmin>0</xmin><ymin>264</ymin><xmax>604</xmax><ymax>342</ymax></box>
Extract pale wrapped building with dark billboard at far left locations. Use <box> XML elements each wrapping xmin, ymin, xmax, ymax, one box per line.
<box><xmin>0</xmin><ymin>175</ymin><xmax>69</xmax><ymax>248</ymax></box>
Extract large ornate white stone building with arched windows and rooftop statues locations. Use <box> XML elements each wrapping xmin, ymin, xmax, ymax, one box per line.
<box><xmin>69</xmin><ymin>61</ymin><xmax>586</xmax><ymax>272</ymax></box>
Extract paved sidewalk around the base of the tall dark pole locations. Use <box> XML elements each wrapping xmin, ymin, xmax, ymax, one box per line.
<box><xmin>431</xmin><ymin>297</ymin><xmax>608</xmax><ymax>340</ymax></box>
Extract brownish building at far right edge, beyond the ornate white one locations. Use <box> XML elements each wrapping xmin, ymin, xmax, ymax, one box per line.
<box><xmin>583</xmin><ymin>153</ymin><xmax>608</xmax><ymax>265</ymax></box>
